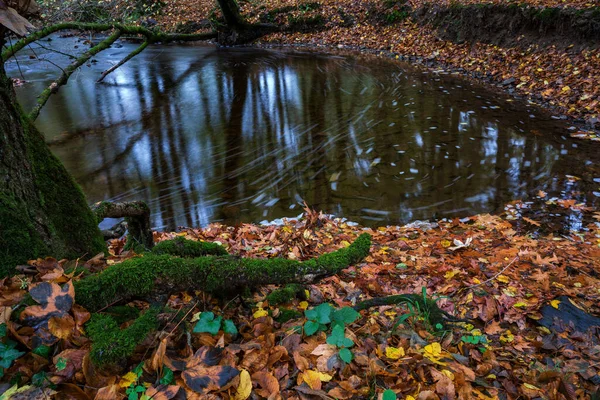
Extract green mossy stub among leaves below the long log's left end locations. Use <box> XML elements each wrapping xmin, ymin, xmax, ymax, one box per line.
<box><xmin>86</xmin><ymin>308</ymin><xmax>158</xmax><ymax>366</ymax></box>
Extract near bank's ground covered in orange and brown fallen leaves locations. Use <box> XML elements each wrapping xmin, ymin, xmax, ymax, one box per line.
<box><xmin>0</xmin><ymin>205</ymin><xmax>600</xmax><ymax>400</ymax></box>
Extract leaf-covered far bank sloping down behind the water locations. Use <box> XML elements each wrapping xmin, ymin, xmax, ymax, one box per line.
<box><xmin>158</xmin><ymin>0</ymin><xmax>600</xmax><ymax>140</ymax></box>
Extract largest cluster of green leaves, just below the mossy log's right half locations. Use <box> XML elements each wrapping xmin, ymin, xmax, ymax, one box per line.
<box><xmin>304</xmin><ymin>303</ymin><xmax>360</xmax><ymax>363</ymax></box>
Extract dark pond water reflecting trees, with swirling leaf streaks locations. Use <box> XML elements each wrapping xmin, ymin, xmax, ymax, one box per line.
<box><xmin>8</xmin><ymin>39</ymin><xmax>600</xmax><ymax>229</ymax></box>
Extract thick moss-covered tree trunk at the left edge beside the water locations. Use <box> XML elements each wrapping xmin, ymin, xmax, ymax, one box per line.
<box><xmin>0</xmin><ymin>28</ymin><xmax>105</xmax><ymax>277</ymax></box>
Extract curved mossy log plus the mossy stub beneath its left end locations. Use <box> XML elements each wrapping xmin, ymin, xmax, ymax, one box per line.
<box><xmin>82</xmin><ymin>234</ymin><xmax>371</xmax><ymax>369</ymax></box>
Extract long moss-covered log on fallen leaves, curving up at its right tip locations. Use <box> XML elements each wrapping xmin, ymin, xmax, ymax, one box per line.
<box><xmin>75</xmin><ymin>234</ymin><xmax>371</xmax><ymax>311</ymax></box>
